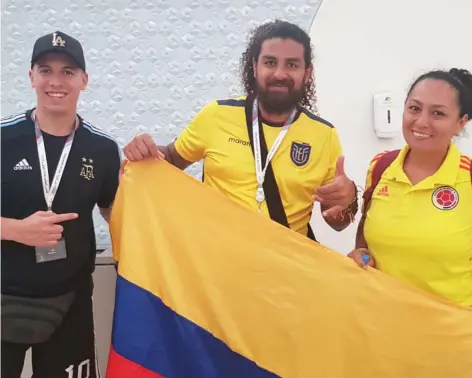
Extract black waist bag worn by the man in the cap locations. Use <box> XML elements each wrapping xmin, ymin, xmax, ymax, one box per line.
<box><xmin>2</xmin><ymin>292</ymin><xmax>75</xmax><ymax>345</ymax></box>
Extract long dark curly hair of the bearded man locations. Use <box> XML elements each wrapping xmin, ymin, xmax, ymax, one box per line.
<box><xmin>240</xmin><ymin>20</ymin><xmax>317</xmax><ymax>113</ymax></box>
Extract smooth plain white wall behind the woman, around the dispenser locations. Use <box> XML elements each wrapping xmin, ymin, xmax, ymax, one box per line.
<box><xmin>310</xmin><ymin>0</ymin><xmax>472</xmax><ymax>253</ymax></box>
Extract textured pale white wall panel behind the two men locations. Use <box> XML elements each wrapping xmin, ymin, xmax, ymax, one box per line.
<box><xmin>1</xmin><ymin>0</ymin><xmax>321</xmax><ymax>245</ymax></box>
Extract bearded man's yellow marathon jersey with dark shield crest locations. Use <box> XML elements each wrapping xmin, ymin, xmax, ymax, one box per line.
<box><xmin>175</xmin><ymin>98</ymin><xmax>341</xmax><ymax>235</ymax></box>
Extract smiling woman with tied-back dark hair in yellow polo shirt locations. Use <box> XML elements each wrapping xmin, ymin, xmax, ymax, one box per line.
<box><xmin>349</xmin><ymin>68</ymin><xmax>472</xmax><ymax>306</ymax></box>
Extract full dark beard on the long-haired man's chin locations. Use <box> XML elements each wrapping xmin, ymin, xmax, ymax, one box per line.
<box><xmin>257</xmin><ymin>84</ymin><xmax>305</xmax><ymax>114</ymax></box>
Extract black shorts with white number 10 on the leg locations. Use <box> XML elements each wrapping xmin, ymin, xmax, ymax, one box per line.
<box><xmin>1</xmin><ymin>290</ymin><xmax>99</xmax><ymax>378</ymax></box>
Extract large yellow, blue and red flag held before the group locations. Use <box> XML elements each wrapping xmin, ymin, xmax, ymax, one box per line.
<box><xmin>107</xmin><ymin>161</ymin><xmax>472</xmax><ymax>378</ymax></box>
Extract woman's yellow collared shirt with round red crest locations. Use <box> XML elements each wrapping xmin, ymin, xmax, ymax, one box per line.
<box><xmin>364</xmin><ymin>143</ymin><xmax>472</xmax><ymax>306</ymax></box>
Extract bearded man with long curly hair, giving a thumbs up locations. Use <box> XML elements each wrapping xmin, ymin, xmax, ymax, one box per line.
<box><xmin>124</xmin><ymin>20</ymin><xmax>358</xmax><ymax>240</ymax></box>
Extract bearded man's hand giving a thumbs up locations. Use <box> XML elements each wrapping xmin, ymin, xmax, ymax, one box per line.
<box><xmin>313</xmin><ymin>156</ymin><xmax>356</xmax><ymax>218</ymax></box>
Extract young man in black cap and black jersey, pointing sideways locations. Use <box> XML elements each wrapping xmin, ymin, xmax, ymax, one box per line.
<box><xmin>1</xmin><ymin>31</ymin><xmax>121</xmax><ymax>378</ymax></box>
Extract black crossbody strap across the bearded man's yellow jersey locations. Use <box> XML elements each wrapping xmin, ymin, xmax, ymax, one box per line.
<box><xmin>245</xmin><ymin>95</ymin><xmax>317</xmax><ymax>241</ymax></box>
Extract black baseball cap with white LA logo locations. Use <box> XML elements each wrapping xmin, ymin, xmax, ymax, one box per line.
<box><xmin>31</xmin><ymin>30</ymin><xmax>86</xmax><ymax>72</ymax></box>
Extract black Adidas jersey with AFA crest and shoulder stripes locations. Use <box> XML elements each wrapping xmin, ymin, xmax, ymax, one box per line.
<box><xmin>1</xmin><ymin>110</ymin><xmax>121</xmax><ymax>296</ymax></box>
